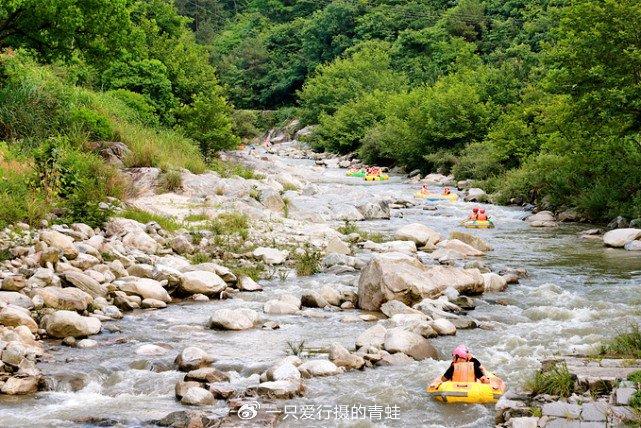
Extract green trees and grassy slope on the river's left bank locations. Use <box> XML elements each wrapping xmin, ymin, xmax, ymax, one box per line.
<box><xmin>0</xmin><ymin>0</ymin><xmax>240</xmax><ymax>227</ymax></box>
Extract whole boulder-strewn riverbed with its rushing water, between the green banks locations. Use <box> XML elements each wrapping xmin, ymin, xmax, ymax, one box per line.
<box><xmin>0</xmin><ymin>142</ymin><xmax>641</xmax><ymax>426</ymax></box>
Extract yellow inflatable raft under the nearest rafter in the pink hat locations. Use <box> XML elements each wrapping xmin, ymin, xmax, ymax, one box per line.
<box><xmin>427</xmin><ymin>373</ymin><xmax>507</xmax><ymax>404</ymax></box>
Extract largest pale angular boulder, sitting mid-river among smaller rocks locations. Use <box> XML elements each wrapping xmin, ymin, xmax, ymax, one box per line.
<box><xmin>358</xmin><ymin>253</ymin><xmax>484</xmax><ymax>311</ymax></box>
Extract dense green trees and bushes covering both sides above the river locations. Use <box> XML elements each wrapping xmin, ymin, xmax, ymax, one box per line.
<box><xmin>0</xmin><ymin>0</ymin><xmax>641</xmax><ymax>227</ymax></box>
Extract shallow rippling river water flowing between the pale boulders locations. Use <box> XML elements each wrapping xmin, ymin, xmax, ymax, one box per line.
<box><xmin>0</xmin><ymin>149</ymin><xmax>641</xmax><ymax>427</ymax></box>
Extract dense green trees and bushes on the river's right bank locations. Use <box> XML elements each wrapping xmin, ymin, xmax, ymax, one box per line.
<box><xmin>200</xmin><ymin>0</ymin><xmax>641</xmax><ymax>220</ymax></box>
